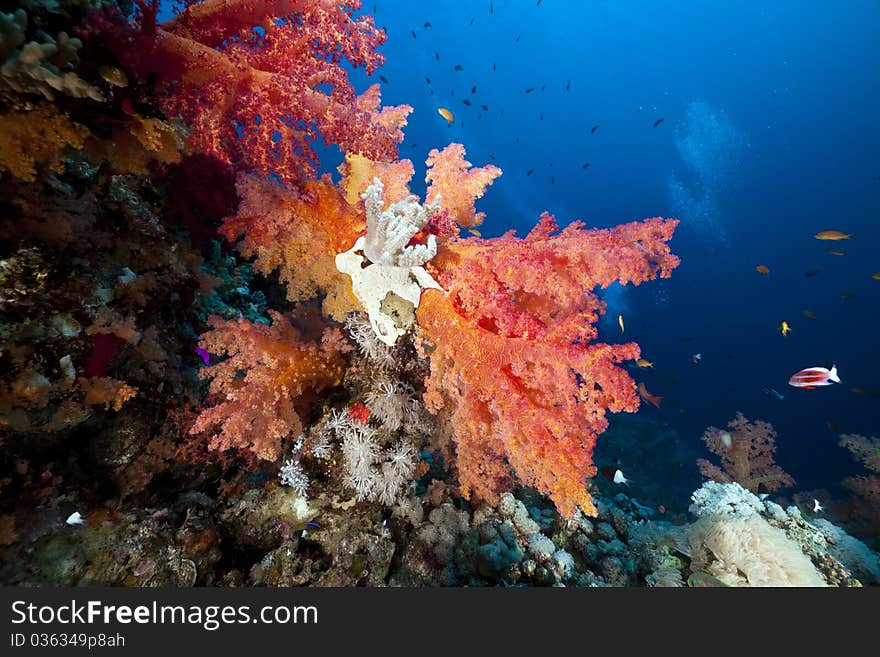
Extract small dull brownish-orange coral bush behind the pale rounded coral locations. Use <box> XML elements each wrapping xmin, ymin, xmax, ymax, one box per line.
<box><xmin>697</xmin><ymin>411</ymin><xmax>794</xmax><ymax>493</ymax></box>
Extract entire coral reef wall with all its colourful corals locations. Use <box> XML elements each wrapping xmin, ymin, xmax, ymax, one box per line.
<box><xmin>0</xmin><ymin>0</ymin><xmax>880</xmax><ymax>587</ymax></box>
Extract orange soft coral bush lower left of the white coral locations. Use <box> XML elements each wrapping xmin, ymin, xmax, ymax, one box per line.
<box><xmin>190</xmin><ymin>311</ymin><xmax>343</xmax><ymax>461</ymax></box>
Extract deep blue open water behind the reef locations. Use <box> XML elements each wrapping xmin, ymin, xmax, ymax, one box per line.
<box><xmin>162</xmin><ymin>0</ymin><xmax>880</xmax><ymax>494</ymax></box>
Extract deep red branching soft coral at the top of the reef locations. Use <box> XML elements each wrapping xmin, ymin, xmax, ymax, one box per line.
<box><xmin>101</xmin><ymin>0</ymin><xmax>412</xmax><ymax>183</ymax></box>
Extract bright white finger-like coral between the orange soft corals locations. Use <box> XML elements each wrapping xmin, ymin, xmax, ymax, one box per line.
<box><xmin>336</xmin><ymin>178</ymin><xmax>442</xmax><ymax>346</ymax></box>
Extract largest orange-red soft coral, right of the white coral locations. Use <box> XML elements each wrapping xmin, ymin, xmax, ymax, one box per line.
<box><xmin>417</xmin><ymin>210</ymin><xmax>678</xmax><ymax>517</ymax></box>
